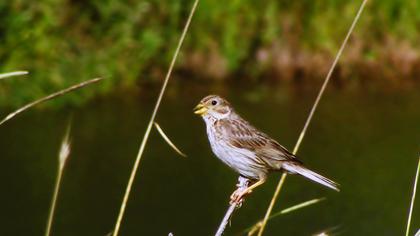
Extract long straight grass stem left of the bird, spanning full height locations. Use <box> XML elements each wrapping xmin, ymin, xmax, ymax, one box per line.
<box><xmin>113</xmin><ymin>0</ymin><xmax>199</xmax><ymax>236</ymax></box>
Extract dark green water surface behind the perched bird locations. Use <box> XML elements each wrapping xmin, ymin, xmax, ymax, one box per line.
<box><xmin>0</xmin><ymin>83</ymin><xmax>420</xmax><ymax>236</ymax></box>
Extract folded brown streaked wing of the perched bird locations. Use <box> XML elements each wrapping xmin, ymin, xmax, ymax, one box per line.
<box><xmin>219</xmin><ymin>120</ymin><xmax>300</xmax><ymax>167</ymax></box>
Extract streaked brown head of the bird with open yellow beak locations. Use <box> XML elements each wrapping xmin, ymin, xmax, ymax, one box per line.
<box><xmin>194</xmin><ymin>95</ymin><xmax>233</xmax><ymax>120</ymax></box>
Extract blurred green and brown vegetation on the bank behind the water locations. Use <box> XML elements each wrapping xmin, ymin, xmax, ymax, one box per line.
<box><xmin>0</xmin><ymin>0</ymin><xmax>420</xmax><ymax>106</ymax></box>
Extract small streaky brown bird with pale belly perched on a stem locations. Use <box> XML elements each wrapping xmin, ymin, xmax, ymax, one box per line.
<box><xmin>194</xmin><ymin>95</ymin><xmax>339</xmax><ymax>202</ymax></box>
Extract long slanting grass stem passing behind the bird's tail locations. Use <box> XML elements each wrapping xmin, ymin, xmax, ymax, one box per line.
<box><xmin>258</xmin><ymin>0</ymin><xmax>367</xmax><ymax>236</ymax></box>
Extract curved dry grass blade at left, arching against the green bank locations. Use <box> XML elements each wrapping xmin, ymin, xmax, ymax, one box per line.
<box><xmin>0</xmin><ymin>78</ymin><xmax>102</xmax><ymax>125</ymax></box>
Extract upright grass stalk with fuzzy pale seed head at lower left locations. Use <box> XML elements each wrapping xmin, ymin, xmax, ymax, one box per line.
<box><xmin>45</xmin><ymin>124</ymin><xmax>70</xmax><ymax>236</ymax></box>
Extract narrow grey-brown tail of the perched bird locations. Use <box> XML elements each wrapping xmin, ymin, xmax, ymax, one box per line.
<box><xmin>282</xmin><ymin>162</ymin><xmax>340</xmax><ymax>192</ymax></box>
